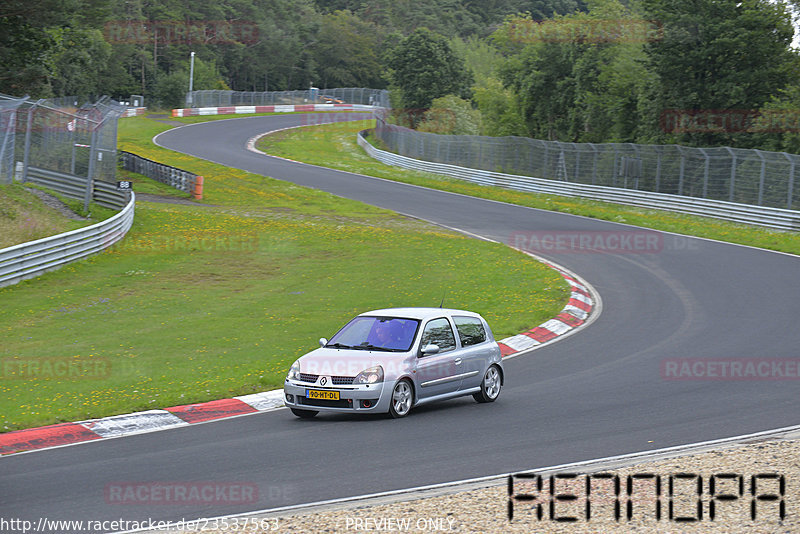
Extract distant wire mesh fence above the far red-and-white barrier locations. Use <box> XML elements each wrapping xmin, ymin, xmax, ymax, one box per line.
<box><xmin>186</xmin><ymin>87</ymin><xmax>390</xmax><ymax>108</ymax></box>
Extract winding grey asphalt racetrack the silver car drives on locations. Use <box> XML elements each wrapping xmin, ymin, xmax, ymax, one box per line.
<box><xmin>0</xmin><ymin>115</ymin><xmax>800</xmax><ymax>523</ymax></box>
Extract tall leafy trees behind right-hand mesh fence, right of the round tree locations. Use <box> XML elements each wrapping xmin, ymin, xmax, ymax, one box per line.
<box><xmin>496</xmin><ymin>0</ymin><xmax>800</xmax><ymax>149</ymax></box>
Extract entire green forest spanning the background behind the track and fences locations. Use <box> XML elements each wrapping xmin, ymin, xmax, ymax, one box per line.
<box><xmin>0</xmin><ymin>0</ymin><xmax>800</xmax><ymax>153</ymax></box>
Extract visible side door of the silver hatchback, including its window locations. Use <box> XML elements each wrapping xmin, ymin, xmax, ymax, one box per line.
<box><xmin>414</xmin><ymin>317</ymin><xmax>461</xmax><ymax>399</ymax></box>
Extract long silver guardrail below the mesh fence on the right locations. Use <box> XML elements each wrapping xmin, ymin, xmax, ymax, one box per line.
<box><xmin>358</xmin><ymin>131</ymin><xmax>800</xmax><ymax>230</ymax></box>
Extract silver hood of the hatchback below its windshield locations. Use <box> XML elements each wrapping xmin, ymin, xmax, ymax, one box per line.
<box><xmin>299</xmin><ymin>347</ymin><xmax>413</xmax><ymax>377</ymax></box>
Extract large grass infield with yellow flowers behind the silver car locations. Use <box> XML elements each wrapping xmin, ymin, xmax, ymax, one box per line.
<box><xmin>0</xmin><ymin>117</ymin><xmax>568</xmax><ymax>431</ymax></box>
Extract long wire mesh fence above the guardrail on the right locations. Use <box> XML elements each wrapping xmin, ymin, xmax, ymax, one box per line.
<box><xmin>375</xmin><ymin>116</ymin><xmax>800</xmax><ymax>209</ymax></box>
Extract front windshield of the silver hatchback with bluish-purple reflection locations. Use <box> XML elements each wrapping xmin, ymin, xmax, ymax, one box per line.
<box><xmin>325</xmin><ymin>316</ymin><xmax>419</xmax><ymax>352</ymax></box>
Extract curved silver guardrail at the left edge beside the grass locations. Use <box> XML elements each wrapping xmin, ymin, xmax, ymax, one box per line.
<box><xmin>0</xmin><ymin>191</ymin><xmax>136</xmax><ymax>287</ymax></box>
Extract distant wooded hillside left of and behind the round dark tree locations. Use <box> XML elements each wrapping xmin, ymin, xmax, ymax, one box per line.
<box><xmin>0</xmin><ymin>0</ymin><xmax>582</xmax><ymax>106</ymax></box>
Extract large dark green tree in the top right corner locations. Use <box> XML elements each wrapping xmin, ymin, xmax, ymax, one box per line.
<box><xmin>643</xmin><ymin>0</ymin><xmax>796</xmax><ymax>146</ymax></box>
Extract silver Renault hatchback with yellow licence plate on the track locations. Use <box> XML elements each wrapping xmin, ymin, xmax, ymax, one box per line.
<box><xmin>283</xmin><ymin>308</ymin><xmax>504</xmax><ymax>418</ymax></box>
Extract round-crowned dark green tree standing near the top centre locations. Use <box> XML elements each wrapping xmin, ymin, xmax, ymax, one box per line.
<box><xmin>388</xmin><ymin>28</ymin><xmax>472</xmax><ymax>119</ymax></box>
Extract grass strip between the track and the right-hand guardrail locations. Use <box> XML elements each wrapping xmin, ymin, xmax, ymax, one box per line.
<box><xmin>257</xmin><ymin>121</ymin><xmax>800</xmax><ymax>254</ymax></box>
